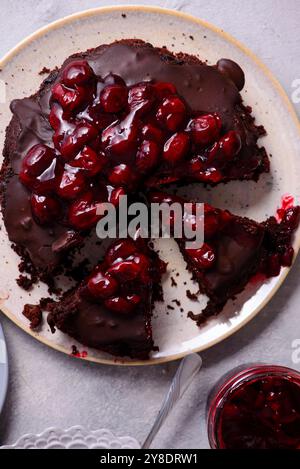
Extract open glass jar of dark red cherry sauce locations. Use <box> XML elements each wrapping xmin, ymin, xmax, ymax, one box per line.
<box><xmin>207</xmin><ymin>364</ymin><xmax>300</xmax><ymax>449</ymax></box>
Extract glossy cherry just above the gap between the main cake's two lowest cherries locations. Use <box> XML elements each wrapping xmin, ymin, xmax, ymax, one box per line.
<box><xmin>57</xmin><ymin>165</ymin><xmax>86</xmax><ymax>199</ymax></box>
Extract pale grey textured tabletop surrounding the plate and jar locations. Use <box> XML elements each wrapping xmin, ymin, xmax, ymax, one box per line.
<box><xmin>0</xmin><ymin>0</ymin><xmax>300</xmax><ymax>448</ymax></box>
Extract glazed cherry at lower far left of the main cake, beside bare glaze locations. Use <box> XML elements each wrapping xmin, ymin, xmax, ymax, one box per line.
<box><xmin>30</xmin><ymin>194</ymin><xmax>61</xmax><ymax>225</ymax></box>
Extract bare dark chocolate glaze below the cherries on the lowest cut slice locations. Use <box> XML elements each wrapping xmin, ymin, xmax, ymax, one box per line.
<box><xmin>48</xmin><ymin>288</ymin><xmax>153</xmax><ymax>358</ymax></box>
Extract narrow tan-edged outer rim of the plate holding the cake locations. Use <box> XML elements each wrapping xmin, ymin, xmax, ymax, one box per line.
<box><xmin>0</xmin><ymin>4</ymin><xmax>300</xmax><ymax>366</ymax></box>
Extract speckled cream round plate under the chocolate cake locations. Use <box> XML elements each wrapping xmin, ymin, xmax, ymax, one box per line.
<box><xmin>0</xmin><ymin>6</ymin><xmax>300</xmax><ymax>364</ymax></box>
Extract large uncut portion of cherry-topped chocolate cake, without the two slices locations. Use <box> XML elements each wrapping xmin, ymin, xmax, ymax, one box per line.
<box><xmin>1</xmin><ymin>40</ymin><xmax>269</xmax><ymax>276</ymax></box>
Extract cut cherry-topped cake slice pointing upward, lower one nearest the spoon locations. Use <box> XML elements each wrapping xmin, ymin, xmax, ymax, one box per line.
<box><xmin>48</xmin><ymin>238</ymin><xmax>165</xmax><ymax>359</ymax></box>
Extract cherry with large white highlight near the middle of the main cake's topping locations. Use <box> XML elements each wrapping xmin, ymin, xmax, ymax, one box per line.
<box><xmin>101</xmin><ymin>114</ymin><xmax>138</xmax><ymax>158</ymax></box>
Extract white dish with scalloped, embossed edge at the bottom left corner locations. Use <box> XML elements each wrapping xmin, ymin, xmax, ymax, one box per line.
<box><xmin>0</xmin><ymin>425</ymin><xmax>140</xmax><ymax>449</ymax></box>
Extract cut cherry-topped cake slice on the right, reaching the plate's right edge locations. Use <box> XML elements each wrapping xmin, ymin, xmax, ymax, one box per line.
<box><xmin>149</xmin><ymin>192</ymin><xmax>300</xmax><ymax>325</ymax></box>
